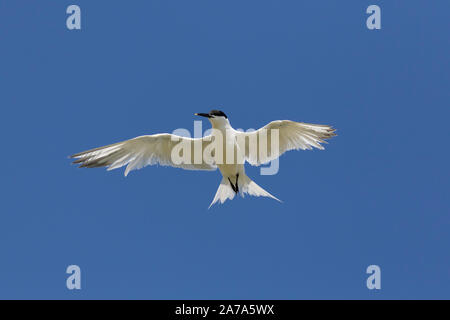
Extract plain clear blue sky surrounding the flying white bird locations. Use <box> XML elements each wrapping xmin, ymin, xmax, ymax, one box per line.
<box><xmin>0</xmin><ymin>0</ymin><xmax>450</xmax><ymax>299</ymax></box>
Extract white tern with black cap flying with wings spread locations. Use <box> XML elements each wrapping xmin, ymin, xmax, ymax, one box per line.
<box><xmin>70</xmin><ymin>110</ymin><xmax>336</xmax><ymax>207</ymax></box>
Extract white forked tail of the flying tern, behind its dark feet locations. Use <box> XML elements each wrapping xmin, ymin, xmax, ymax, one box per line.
<box><xmin>208</xmin><ymin>173</ymin><xmax>281</xmax><ymax>208</ymax></box>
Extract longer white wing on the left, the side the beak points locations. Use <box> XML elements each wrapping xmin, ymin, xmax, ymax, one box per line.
<box><xmin>70</xmin><ymin>133</ymin><xmax>217</xmax><ymax>176</ymax></box>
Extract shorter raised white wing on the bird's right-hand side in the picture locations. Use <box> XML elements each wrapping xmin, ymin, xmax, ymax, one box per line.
<box><xmin>238</xmin><ymin>120</ymin><xmax>336</xmax><ymax>166</ymax></box>
